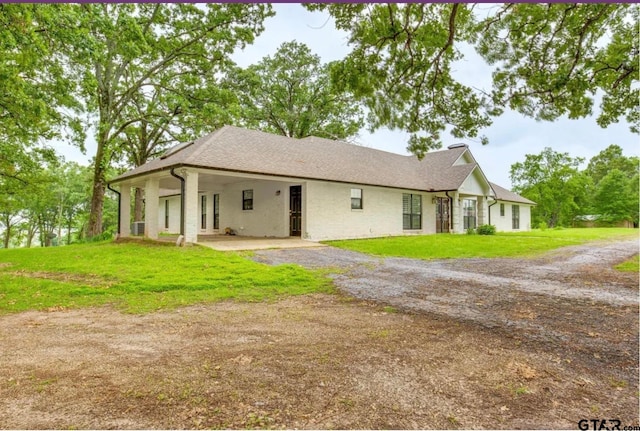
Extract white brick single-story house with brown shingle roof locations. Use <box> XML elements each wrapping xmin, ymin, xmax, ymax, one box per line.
<box><xmin>109</xmin><ymin>126</ymin><xmax>535</xmax><ymax>243</ymax></box>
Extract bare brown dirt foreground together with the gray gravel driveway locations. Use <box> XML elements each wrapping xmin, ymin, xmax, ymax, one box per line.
<box><xmin>0</xmin><ymin>241</ymin><xmax>638</xmax><ymax>429</ymax></box>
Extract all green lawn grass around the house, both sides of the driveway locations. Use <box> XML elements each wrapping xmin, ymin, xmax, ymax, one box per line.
<box><xmin>0</xmin><ymin>228</ymin><xmax>638</xmax><ymax>314</ymax></box>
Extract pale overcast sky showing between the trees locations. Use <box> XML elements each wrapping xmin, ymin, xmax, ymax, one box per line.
<box><xmin>53</xmin><ymin>3</ymin><xmax>640</xmax><ymax>188</ymax></box>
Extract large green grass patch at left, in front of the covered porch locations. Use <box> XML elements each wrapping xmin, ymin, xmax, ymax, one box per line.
<box><xmin>0</xmin><ymin>242</ymin><xmax>332</xmax><ymax>314</ymax></box>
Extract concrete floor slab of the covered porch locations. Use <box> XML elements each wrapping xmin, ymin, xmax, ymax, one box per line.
<box><xmin>159</xmin><ymin>235</ymin><xmax>326</xmax><ymax>251</ymax></box>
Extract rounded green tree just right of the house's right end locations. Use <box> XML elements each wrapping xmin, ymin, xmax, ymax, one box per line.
<box><xmin>510</xmin><ymin>147</ymin><xmax>590</xmax><ymax>227</ymax></box>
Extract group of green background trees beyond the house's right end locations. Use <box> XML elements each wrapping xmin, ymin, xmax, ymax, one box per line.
<box><xmin>511</xmin><ymin>145</ymin><xmax>640</xmax><ymax>227</ymax></box>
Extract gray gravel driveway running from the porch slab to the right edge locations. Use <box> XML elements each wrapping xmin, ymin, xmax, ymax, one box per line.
<box><xmin>254</xmin><ymin>240</ymin><xmax>639</xmax><ymax>368</ymax></box>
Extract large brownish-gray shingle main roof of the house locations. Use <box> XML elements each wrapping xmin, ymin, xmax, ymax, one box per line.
<box><xmin>112</xmin><ymin>126</ymin><xmax>478</xmax><ymax>191</ymax></box>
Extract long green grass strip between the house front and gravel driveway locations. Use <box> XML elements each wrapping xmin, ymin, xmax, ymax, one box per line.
<box><xmin>327</xmin><ymin>228</ymin><xmax>638</xmax><ymax>259</ymax></box>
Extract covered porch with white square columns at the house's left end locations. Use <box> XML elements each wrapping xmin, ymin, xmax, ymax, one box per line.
<box><xmin>117</xmin><ymin>168</ymin><xmax>305</xmax><ymax>243</ymax></box>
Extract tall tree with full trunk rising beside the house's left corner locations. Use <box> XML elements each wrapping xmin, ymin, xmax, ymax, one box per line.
<box><xmin>54</xmin><ymin>3</ymin><xmax>271</xmax><ymax>236</ymax></box>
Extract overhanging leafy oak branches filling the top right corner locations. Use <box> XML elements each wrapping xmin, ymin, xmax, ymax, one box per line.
<box><xmin>477</xmin><ymin>3</ymin><xmax>640</xmax><ymax>133</ymax></box>
